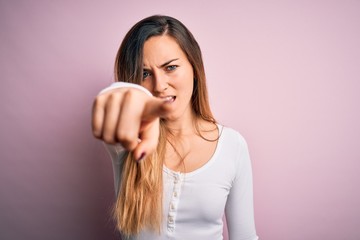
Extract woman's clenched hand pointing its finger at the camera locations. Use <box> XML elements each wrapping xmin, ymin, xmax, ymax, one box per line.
<box><xmin>92</xmin><ymin>88</ymin><xmax>167</xmax><ymax>159</ymax></box>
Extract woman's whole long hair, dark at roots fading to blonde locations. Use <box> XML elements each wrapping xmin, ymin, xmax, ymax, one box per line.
<box><xmin>113</xmin><ymin>15</ymin><xmax>216</xmax><ymax>236</ymax></box>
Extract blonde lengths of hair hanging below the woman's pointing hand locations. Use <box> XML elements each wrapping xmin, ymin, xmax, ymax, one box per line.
<box><xmin>113</xmin><ymin>125</ymin><xmax>165</xmax><ymax>236</ymax></box>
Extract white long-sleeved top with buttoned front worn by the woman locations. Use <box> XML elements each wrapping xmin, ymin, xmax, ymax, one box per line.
<box><xmin>101</xmin><ymin>83</ymin><xmax>258</xmax><ymax>240</ymax></box>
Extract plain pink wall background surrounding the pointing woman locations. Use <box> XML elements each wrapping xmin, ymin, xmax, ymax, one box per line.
<box><xmin>0</xmin><ymin>0</ymin><xmax>360</xmax><ymax>240</ymax></box>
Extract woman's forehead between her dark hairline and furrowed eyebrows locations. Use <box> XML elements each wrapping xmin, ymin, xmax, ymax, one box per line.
<box><xmin>143</xmin><ymin>35</ymin><xmax>186</xmax><ymax>64</ymax></box>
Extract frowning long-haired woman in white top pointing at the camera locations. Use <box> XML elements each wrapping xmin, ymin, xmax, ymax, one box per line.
<box><xmin>92</xmin><ymin>15</ymin><xmax>258</xmax><ymax>240</ymax></box>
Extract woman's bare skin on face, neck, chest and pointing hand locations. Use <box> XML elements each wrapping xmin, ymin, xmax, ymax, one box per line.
<box><xmin>92</xmin><ymin>35</ymin><xmax>218</xmax><ymax>172</ymax></box>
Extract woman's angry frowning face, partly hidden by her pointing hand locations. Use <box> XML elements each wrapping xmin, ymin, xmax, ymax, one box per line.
<box><xmin>142</xmin><ymin>35</ymin><xmax>194</xmax><ymax>120</ymax></box>
